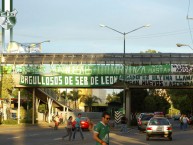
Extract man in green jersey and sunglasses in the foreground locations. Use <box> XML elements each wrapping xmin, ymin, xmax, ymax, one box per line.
<box><xmin>93</xmin><ymin>112</ymin><xmax>110</xmax><ymax>145</ymax></box>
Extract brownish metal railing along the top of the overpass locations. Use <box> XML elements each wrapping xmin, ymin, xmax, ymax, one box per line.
<box><xmin>1</xmin><ymin>53</ymin><xmax>193</xmax><ymax>65</ymax></box>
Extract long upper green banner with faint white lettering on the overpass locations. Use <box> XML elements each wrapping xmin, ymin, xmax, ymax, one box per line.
<box><xmin>52</xmin><ymin>64</ymin><xmax>171</xmax><ymax>75</ymax></box>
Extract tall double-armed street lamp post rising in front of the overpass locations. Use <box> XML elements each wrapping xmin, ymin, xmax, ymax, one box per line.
<box><xmin>100</xmin><ymin>24</ymin><xmax>150</xmax><ymax>119</ymax></box>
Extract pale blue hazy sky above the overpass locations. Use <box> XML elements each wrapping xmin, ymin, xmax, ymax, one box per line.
<box><xmin>1</xmin><ymin>0</ymin><xmax>193</xmax><ymax>53</ymax></box>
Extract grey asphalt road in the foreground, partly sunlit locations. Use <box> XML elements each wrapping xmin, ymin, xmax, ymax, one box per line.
<box><xmin>0</xmin><ymin>122</ymin><xmax>193</xmax><ymax>145</ymax></box>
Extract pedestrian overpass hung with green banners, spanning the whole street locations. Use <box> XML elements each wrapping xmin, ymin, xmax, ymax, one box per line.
<box><xmin>1</xmin><ymin>53</ymin><xmax>193</xmax><ymax>124</ymax></box>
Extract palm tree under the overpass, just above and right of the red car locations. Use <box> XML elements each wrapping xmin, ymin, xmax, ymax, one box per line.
<box><xmin>80</xmin><ymin>95</ymin><xmax>102</xmax><ymax>112</ymax></box>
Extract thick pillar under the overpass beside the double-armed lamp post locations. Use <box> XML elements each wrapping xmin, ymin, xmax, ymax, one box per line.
<box><xmin>125</xmin><ymin>89</ymin><xmax>131</xmax><ymax>125</ymax></box>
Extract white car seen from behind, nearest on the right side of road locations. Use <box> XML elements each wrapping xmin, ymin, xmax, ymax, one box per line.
<box><xmin>146</xmin><ymin>117</ymin><xmax>172</xmax><ymax>140</ymax></box>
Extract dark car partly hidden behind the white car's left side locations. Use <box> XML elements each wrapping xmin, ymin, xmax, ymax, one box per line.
<box><xmin>137</xmin><ymin>113</ymin><xmax>154</xmax><ymax>131</ymax></box>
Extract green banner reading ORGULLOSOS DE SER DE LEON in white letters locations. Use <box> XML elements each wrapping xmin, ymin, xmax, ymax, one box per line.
<box><xmin>20</xmin><ymin>75</ymin><xmax>119</xmax><ymax>87</ymax></box>
